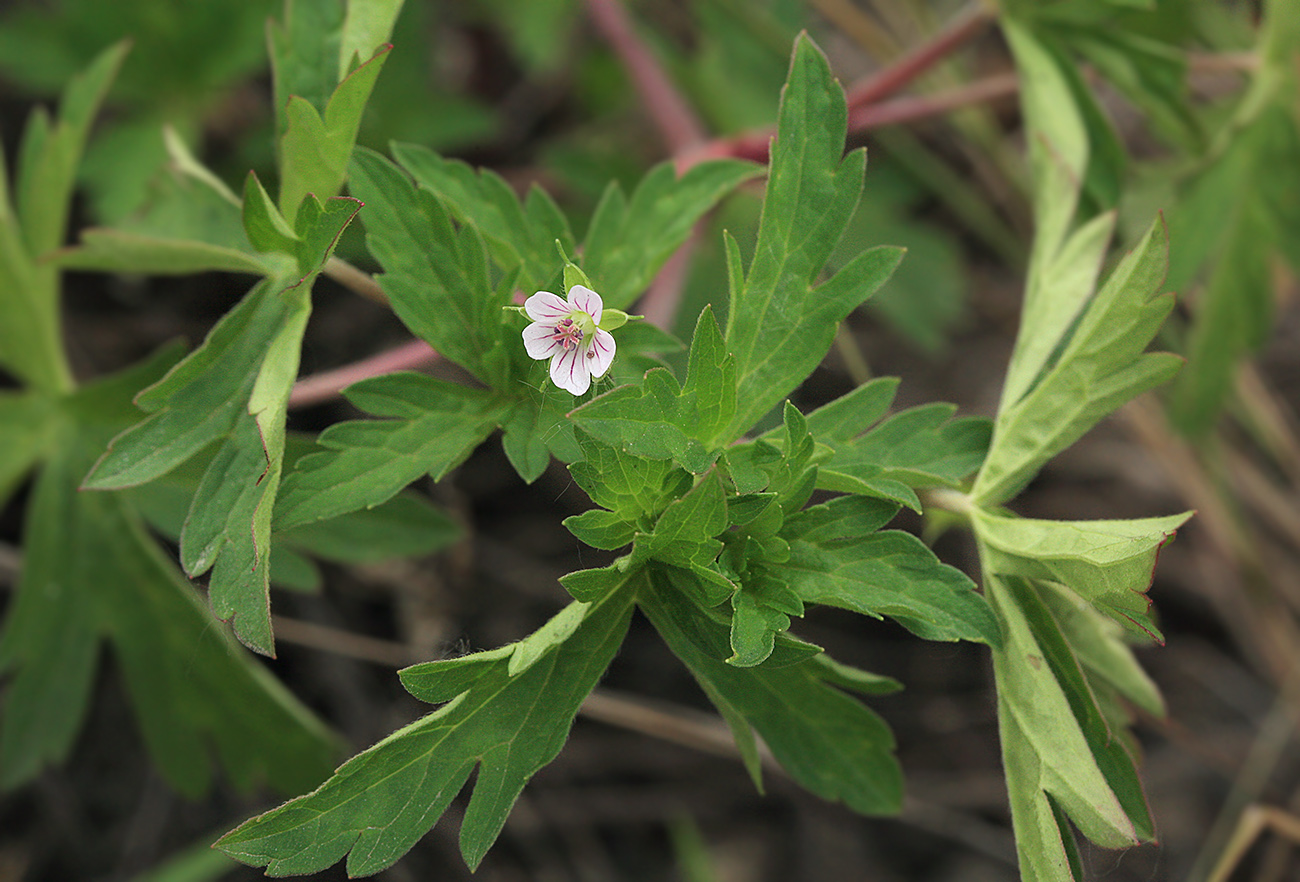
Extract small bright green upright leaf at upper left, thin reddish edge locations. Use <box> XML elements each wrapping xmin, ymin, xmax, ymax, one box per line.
<box><xmin>280</xmin><ymin>46</ymin><xmax>391</xmax><ymax>222</ymax></box>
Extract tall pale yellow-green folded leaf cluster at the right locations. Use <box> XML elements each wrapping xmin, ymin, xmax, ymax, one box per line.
<box><xmin>966</xmin><ymin>8</ymin><xmax>1188</xmax><ymax>882</ymax></box>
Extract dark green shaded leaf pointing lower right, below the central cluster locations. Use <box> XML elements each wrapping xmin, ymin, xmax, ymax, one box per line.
<box><xmin>640</xmin><ymin>576</ymin><xmax>902</xmax><ymax>814</ymax></box>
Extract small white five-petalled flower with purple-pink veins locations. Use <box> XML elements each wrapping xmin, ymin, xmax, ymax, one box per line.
<box><xmin>524</xmin><ymin>285</ymin><xmax>625</xmax><ymax>395</ymax></box>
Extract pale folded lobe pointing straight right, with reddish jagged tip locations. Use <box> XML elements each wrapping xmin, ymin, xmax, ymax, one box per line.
<box><xmin>971</xmin><ymin>510</ymin><xmax>1192</xmax><ymax>640</ymax></box>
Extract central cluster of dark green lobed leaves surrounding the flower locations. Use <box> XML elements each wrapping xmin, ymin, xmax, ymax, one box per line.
<box><xmin>218</xmin><ymin>38</ymin><xmax>1000</xmax><ymax>874</ymax></box>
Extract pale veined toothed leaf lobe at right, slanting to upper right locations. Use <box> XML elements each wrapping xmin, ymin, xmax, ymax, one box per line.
<box><xmin>971</xmin><ymin>221</ymin><xmax>1182</xmax><ymax>507</ymax></box>
